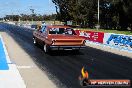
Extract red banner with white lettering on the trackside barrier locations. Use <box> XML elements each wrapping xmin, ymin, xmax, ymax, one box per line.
<box><xmin>75</xmin><ymin>30</ymin><xmax>104</xmax><ymax>43</ymax></box>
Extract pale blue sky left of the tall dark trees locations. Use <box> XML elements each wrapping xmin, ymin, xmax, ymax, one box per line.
<box><xmin>0</xmin><ymin>0</ymin><xmax>56</xmax><ymax>18</ymax></box>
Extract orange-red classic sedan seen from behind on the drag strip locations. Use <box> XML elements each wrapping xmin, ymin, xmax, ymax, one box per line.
<box><xmin>33</xmin><ymin>25</ymin><xmax>86</xmax><ymax>52</ymax></box>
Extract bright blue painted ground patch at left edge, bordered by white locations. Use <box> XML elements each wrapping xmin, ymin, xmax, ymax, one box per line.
<box><xmin>0</xmin><ymin>38</ymin><xmax>9</xmax><ymax>70</ymax></box>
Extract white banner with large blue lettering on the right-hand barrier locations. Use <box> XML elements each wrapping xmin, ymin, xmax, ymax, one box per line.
<box><xmin>103</xmin><ymin>33</ymin><xmax>132</xmax><ymax>51</ymax></box>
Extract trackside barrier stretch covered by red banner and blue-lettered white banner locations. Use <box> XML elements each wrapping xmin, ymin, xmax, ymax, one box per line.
<box><xmin>75</xmin><ymin>29</ymin><xmax>132</xmax><ymax>52</ymax></box>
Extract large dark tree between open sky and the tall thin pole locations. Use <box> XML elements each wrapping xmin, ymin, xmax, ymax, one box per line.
<box><xmin>52</xmin><ymin>0</ymin><xmax>97</xmax><ymax>25</ymax></box>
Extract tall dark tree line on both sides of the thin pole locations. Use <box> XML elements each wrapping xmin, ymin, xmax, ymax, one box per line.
<box><xmin>52</xmin><ymin>0</ymin><xmax>132</xmax><ymax>30</ymax></box>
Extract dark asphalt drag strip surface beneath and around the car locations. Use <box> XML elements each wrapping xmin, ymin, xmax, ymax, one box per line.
<box><xmin>0</xmin><ymin>23</ymin><xmax>132</xmax><ymax>88</ymax></box>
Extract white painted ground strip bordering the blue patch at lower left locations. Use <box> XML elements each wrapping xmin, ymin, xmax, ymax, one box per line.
<box><xmin>0</xmin><ymin>35</ymin><xmax>26</xmax><ymax>88</ymax></box>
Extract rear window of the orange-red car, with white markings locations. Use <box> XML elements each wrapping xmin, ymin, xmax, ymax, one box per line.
<box><xmin>49</xmin><ymin>28</ymin><xmax>76</xmax><ymax>35</ymax></box>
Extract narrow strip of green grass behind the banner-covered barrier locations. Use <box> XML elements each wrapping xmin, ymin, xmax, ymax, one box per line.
<box><xmin>76</xmin><ymin>28</ymin><xmax>132</xmax><ymax>35</ymax></box>
